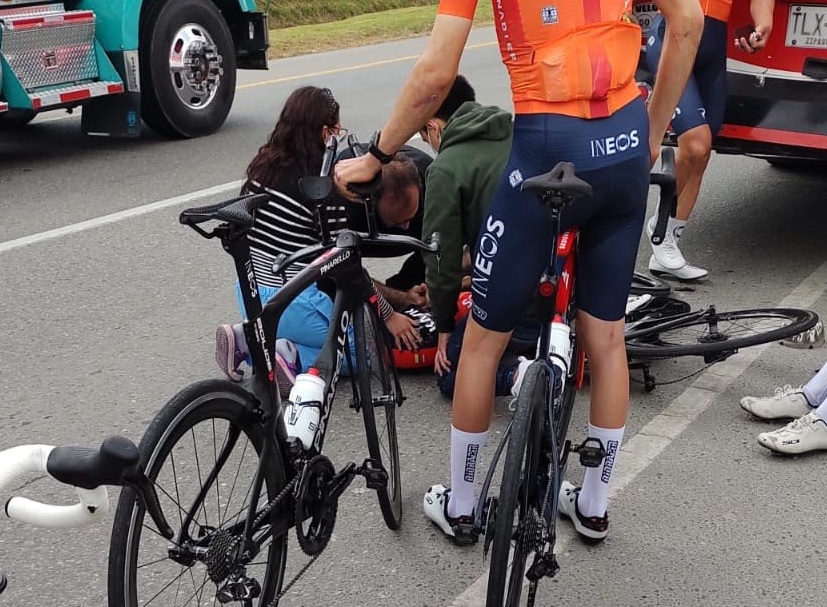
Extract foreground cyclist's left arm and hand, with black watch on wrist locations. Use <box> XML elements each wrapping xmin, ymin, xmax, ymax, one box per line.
<box><xmin>334</xmin><ymin>6</ymin><xmax>476</xmax><ymax>190</ymax></box>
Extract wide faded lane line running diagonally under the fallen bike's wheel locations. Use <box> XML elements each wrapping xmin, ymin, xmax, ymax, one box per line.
<box><xmin>450</xmin><ymin>262</ymin><xmax>827</xmax><ymax>607</ymax></box>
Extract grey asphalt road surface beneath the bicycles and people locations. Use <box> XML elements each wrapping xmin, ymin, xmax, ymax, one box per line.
<box><xmin>0</xmin><ymin>29</ymin><xmax>827</xmax><ymax>607</ymax></box>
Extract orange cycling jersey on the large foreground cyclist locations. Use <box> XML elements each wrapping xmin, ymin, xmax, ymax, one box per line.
<box><xmin>438</xmin><ymin>0</ymin><xmax>644</xmax><ymax>118</ymax></box>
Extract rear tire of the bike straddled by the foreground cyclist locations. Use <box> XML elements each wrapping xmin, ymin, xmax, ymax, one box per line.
<box><xmin>486</xmin><ymin>361</ymin><xmax>556</xmax><ymax>607</ymax></box>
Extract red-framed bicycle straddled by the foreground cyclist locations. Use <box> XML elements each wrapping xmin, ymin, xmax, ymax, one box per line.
<box><xmin>474</xmin><ymin>148</ymin><xmax>716</xmax><ymax>607</ymax></box>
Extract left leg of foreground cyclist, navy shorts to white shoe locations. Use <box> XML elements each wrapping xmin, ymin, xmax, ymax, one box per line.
<box><xmin>424</xmin><ymin>116</ymin><xmax>554</xmax><ymax>543</ymax></box>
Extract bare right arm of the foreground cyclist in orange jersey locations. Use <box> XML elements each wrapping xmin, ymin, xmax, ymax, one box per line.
<box><xmin>649</xmin><ymin>0</ymin><xmax>704</xmax><ymax>164</ymax></box>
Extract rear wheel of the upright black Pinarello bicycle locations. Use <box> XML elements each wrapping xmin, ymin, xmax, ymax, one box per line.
<box><xmin>108</xmin><ymin>380</ymin><xmax>287</xmax><ymax>607</ymax></box>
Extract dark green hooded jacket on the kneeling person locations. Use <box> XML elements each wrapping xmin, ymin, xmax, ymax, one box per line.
<box><xmin>422</xmin><ymin>101</ymin><xmax>512</xmax><ymax>333</ymax></box>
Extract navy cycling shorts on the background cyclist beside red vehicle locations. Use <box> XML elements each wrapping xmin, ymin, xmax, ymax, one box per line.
<box><xmin>646</xmin><ymin>14</ymin><xmax>727</xmax><ymax>137</ymax></box>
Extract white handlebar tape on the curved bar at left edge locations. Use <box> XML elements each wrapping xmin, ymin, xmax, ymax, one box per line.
<box><xmin>0</xmin><ymin>445</ymin><xmax>109</xmax><ymax>529</ymax></box>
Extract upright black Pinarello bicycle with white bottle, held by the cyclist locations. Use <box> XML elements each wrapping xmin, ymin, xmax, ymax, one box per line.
<box><xmin>108</xmin><ymin>137</ymin><xmax>439</xmax><ymax>607</ymax></box>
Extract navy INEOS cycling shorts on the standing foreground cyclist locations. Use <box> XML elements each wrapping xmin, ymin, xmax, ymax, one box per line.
<box><xmin>472</xmin><ymin>99</ymin><xmax>650</xmax><ymax>332</ymax></box>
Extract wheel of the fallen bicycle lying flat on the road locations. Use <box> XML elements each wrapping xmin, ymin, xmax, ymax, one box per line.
<box><xmin>626</xmin><ymin>308</ymin><xmax>818</xmax><ymax>359</ymax></box>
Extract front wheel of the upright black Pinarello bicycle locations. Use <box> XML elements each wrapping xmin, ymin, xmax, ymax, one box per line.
<box><xmin>353</xmin><ymin>304</ymin><xmax>402</xmax><ymax>529</ymax></box>
